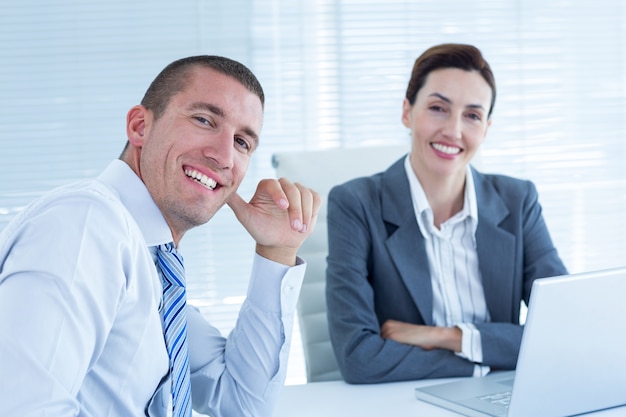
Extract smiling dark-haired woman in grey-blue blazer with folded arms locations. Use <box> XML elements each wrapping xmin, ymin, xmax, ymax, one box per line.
<box><xmin>326</xmin><ymin>44</ymin><xmax>567</xmax><ymax>383</ymax></box>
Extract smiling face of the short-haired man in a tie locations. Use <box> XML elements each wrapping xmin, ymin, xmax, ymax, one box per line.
<box><xmin>138</xmin><ymin>67</ymin><xmax>263</xmax><ymax>241</ymax></box>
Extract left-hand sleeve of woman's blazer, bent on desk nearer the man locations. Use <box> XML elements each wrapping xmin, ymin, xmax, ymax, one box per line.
<box><xmin>326</xmin><ymin>178</ymin><xmax>474</xmax><ymax>383</ymax></box>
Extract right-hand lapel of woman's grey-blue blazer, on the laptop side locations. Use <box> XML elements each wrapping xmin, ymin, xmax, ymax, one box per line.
<box><xmin>472</xmin><ymin>169</ymin><xmax>518</xmax><ymax>322</ymax></box>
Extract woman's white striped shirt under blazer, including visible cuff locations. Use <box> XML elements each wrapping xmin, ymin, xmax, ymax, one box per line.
<box><xmin>404</xmin><ymin>156</ymin><xmax>490</xmax><ymax>376</ymax></box>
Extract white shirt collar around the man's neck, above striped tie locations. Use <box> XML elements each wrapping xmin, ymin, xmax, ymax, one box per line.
<box><xmin>98</xmin><ymin>159</ymin><xmax>173</xmax><ymax>246</ymax></box>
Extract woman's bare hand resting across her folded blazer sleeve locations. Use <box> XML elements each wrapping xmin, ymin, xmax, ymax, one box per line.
<box><xmin>380</xmin><ymin>320</ymin><xmax>462</xmax><ymax>352</ymax></box>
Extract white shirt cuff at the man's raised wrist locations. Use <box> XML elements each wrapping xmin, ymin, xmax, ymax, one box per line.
<box><xmin>247</xmin><ymin>254</ymin><xmax>306</xmax><ymax>315</ymax></box>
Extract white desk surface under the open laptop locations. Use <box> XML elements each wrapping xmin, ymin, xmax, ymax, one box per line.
<box><xmin>274</xmin><ymin>379</ymin><xmax>626</xmax><ymax>417</ymax></box>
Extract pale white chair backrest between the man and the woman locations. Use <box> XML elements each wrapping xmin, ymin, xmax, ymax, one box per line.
<box><xmin>272</xmin><ymin>143</ymin><xmax>410</xmax><ymax>382</ymax></box>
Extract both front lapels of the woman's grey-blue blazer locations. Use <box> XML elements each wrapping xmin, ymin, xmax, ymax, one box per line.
<box><xmin>372</xmin><ymin>162</ymin><xmax>519</xmax><ymax>325</ymax></box>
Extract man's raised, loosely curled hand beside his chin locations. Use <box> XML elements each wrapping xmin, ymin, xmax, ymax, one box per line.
<box><xmin>228</xmin><ymin>178</ymin><xmax>322</xmax><ymax>266</ymax></box>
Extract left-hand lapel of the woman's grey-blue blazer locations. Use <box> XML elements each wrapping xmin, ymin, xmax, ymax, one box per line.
<box><xmin>382</xmin><ymin>158</ymin><xmax>433</xmax><ymax>325</ymax></box>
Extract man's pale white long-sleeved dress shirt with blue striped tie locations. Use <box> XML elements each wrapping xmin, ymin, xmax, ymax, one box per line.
<box><xmin>0</xmin><ymin>160</ymin><xmax>305</xmax><ymax>417</ymax></box>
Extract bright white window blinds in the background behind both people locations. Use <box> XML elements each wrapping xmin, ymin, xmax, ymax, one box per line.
<box><xmin>0</xmin><ymin>0</ymin><xmax>626</xmax><ymax>382</ymax></box>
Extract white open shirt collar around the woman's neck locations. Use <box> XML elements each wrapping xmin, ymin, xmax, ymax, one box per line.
<box><xmin>404</xmin><ymin>154</ymin><xmax>478</xmax><ymax>239</ymax></box>
